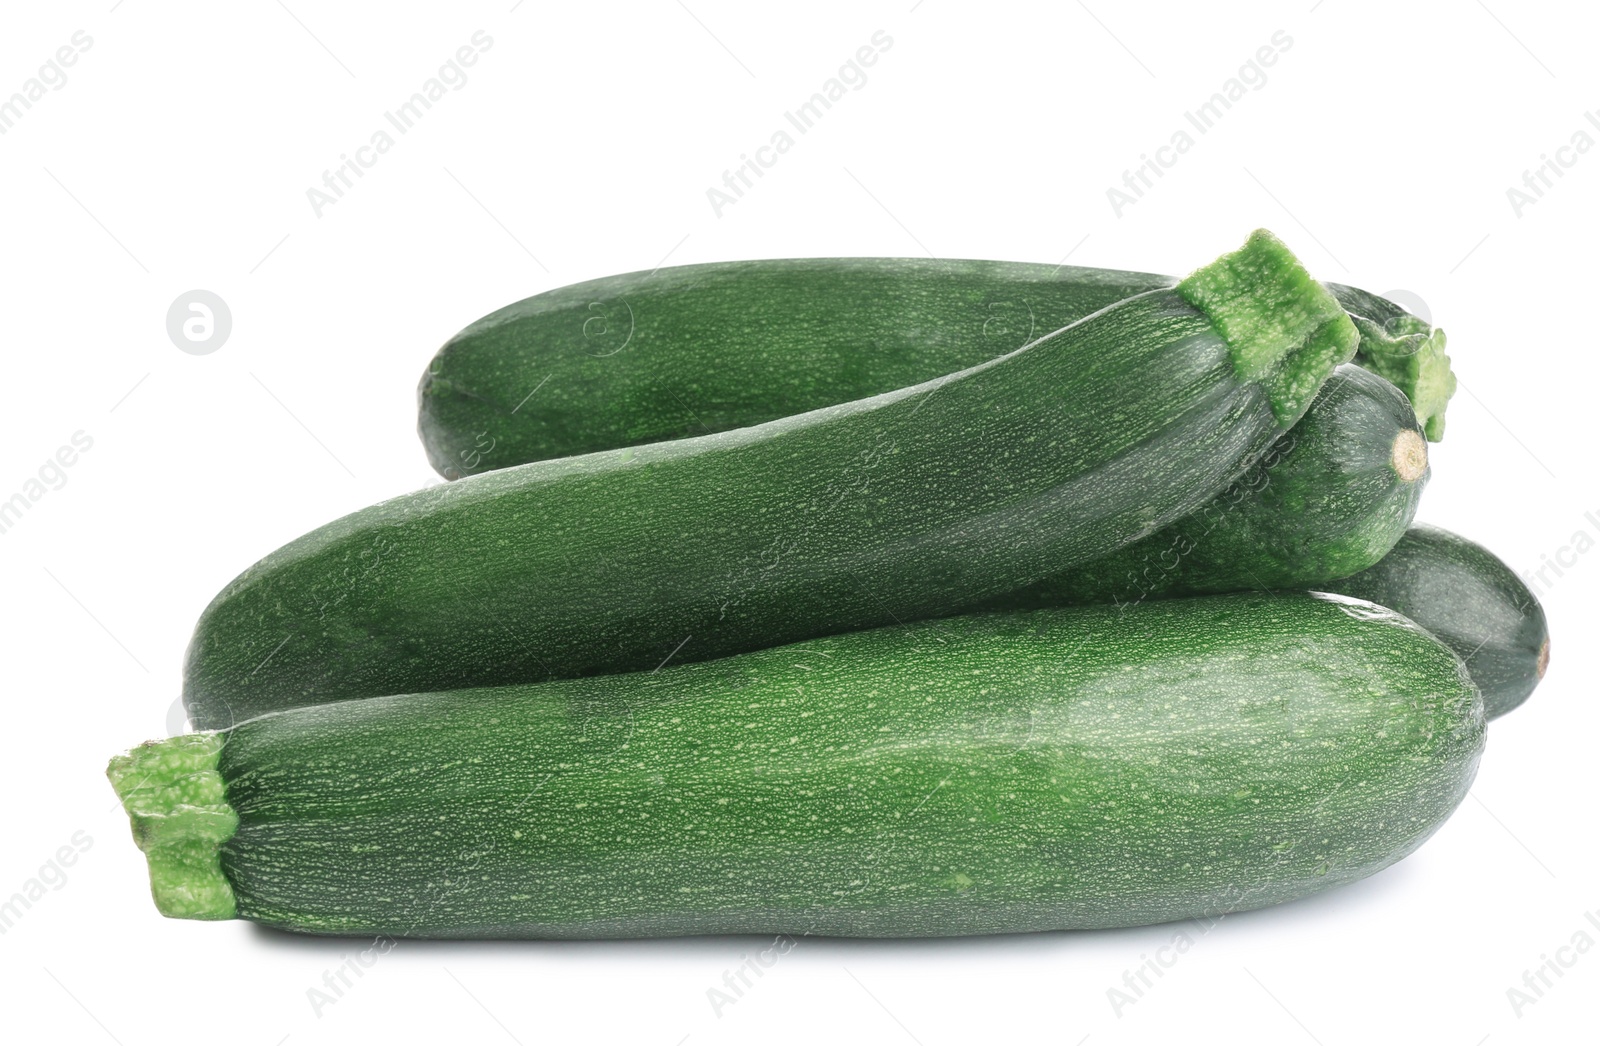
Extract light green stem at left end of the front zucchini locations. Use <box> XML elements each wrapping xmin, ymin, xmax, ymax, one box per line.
<box><xmin>106</xmin><ymin>733</ymin><xmax>238</xmax><ymax>920</ymax></box>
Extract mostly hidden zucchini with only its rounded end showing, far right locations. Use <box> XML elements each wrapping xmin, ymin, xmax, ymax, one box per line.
<box><xmin>1330</xmin><ymin>525</ymin><xmax>1550</xmax><ymax>718</ymax></box>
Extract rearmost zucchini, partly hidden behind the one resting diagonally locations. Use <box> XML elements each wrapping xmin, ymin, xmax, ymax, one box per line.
<box><xmin>418</xmin><ymin>258</ymin><xmax>1454</xmax><ymax>480</ymax></box>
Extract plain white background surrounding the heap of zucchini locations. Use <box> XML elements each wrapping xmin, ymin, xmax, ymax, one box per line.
<box><xmin>0</xmin><ymin>0</ymin><xmax>1600</xmax><ymax>1046</ymax></box>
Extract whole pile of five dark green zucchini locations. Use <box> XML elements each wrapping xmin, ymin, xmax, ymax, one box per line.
<box><xmin>109</xmin><ymin>232</ymin><xmax>1549</xmax><ymax>937</ymax></box>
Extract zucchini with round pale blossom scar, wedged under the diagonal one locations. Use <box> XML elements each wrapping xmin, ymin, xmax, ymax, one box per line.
<box><xmin>984</xmin><ymin>366</ymin><xmax>1430</xmax><ymax>613</ymax></box>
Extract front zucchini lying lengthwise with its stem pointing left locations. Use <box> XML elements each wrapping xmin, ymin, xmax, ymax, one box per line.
<box><xmin>109</xmin><ymin>593</ymin><xmax>1483</xmax><ymax>937</ymax></box>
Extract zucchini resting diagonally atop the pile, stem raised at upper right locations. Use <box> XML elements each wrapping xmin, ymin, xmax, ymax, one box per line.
<box><xmin>184</xmin><ymin>232</ymin><xmax>1357</xmax><ymax>729</ymax></box>
